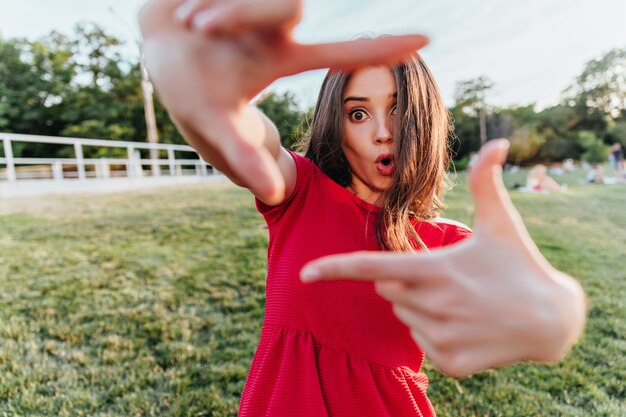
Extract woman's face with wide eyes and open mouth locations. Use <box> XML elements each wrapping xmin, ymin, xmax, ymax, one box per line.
<box><xmin>342</xmin><ymin>66</ymin><xmax>397</xmax><ymax>204</ymax></box>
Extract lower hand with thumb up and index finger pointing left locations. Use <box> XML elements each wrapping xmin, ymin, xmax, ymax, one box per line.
<box><xmin>301</xmin><ymin>140</ymin><xmax>586</xmax><ymax>377</ymax></box>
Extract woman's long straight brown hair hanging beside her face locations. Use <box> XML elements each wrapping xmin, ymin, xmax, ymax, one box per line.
<box><xmin>302</xmin><ymin>54</ymin><xmax>450</xmax><ymax>252</ymax></box>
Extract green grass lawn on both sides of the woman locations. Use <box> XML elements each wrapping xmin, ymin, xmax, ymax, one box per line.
<box><xmin>0</xmin><ymin>171</ymin><xmax>626</xmax><ymax>417</ymax></box>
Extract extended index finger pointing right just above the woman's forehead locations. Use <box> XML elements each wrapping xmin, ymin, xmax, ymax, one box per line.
<box><xmin>284</xmin><ymin>35</ymin><xmax>428</xmax><ymax>75</ymax></box>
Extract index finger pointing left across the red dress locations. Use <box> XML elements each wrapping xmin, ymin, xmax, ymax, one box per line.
<box><xmin>300</xmin><ymin>250</ymin><xmax>447</xmax><ymax>284</ymax></box>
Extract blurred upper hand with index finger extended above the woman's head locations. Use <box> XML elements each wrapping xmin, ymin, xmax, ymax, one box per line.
<box><xmin>139</xmin><ymin>0</ymin><xmax>428</xmax><ymax>201</ymax></box>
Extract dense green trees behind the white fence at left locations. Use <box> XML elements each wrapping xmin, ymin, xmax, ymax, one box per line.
<box><xmin>0</xmin><ymin>23</ymin><xmax>184</xmax><ymax>157</ymax></box>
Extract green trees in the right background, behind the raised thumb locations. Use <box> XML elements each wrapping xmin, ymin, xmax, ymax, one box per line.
<box><xmin>450</xmin><ymin>49</ymin><xmax>626</xmax><ymax>164</ymax></box>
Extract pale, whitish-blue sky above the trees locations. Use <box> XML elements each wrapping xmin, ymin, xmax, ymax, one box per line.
<box><xmin>0</xmin><ymin>0</ymin><xmax>626</xmax><ymax>108</ymax></box>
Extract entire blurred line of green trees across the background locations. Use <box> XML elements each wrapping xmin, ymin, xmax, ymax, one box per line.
<box><xmin>0</xmin><ymin>24</ymin><xmax>626</xmax><ymax>167</ymax></box>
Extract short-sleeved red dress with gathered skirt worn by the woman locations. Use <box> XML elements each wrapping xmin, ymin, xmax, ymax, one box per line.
<box><xmin>239</xmin><ymin>154</ymin><xmax>471</xmax><ymax>417</ymax></box>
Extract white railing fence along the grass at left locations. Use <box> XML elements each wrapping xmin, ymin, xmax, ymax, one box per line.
<box><xmin>0</xmin><ymin>133</ymin><xmax>217</xmax><ymax>183</ymax></box>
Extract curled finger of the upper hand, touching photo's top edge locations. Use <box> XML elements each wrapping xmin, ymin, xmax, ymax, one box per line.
<box><xmin>190</xmin><ymin>0</ymin><xmax>302</xmax><ymax>35</ymax></box>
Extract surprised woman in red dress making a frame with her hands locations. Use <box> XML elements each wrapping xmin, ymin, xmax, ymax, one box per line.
<box><xmin>140</xmin><ymin>0</ymin><xmax>584</xmax><ymax>416</ymax></box>
